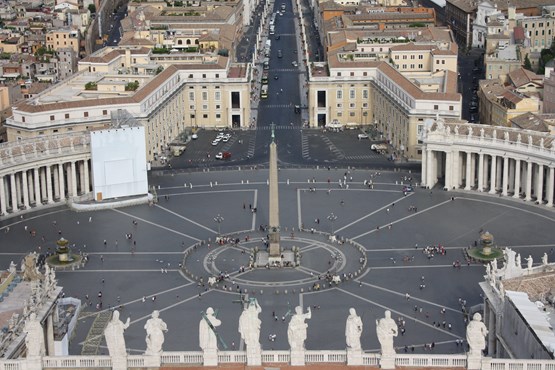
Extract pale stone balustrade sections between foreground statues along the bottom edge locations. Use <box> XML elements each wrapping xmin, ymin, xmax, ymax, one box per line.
<box><xmin>0</xmin><ymin>351</ymin><xmax>555</xmax><ymax>370</ymax></box>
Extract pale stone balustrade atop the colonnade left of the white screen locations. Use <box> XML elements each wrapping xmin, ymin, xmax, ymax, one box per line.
<box><xmin>0</xmin><ymin>132</ymin><xmax>91</xmax><ymax>174</ymax></box>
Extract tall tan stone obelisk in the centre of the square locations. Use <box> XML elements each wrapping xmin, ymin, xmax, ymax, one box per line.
<box><xmin>268</xmin><ymin>124</ymin><xmax>281</xmax><ymax>261</ymax></box>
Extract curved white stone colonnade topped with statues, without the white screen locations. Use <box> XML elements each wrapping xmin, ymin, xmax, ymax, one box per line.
<box><xmin>422</xmin><ymin>122</ymin><xmax>555</xmax><ymax>207</ymax></box>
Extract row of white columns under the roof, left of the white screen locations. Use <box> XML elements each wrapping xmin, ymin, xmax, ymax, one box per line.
<box><xmin>0</xmin><ymin>159</ymin><xmax>91</xmax><ymax>215</ymax></box>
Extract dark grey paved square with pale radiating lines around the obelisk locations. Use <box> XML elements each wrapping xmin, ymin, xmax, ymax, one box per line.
<box><xmin>0</xmin><ymin>168</ymin><xmax>555</xmax><ymax>354</ymax></box>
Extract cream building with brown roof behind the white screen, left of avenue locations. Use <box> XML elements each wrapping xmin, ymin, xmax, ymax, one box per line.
<box><xmin>6</xmin><ymin>47</ymin><xmax>250</xmax><ymax>160</ymax></box>
